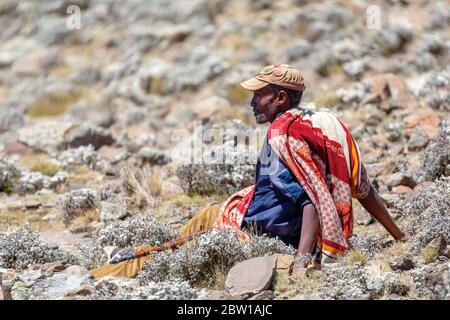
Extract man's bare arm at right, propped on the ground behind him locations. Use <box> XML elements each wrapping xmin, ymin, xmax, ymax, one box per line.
<box><xmin>358</xmin><ymin>186</ymin><xmax>410</xmax><ymax>240</ymax></box>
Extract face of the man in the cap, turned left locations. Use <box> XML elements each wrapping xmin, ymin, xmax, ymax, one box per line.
<box><xmin>250</xmin><ymin>86</ymin><xmax>279</xmax><ymax>124</ymax></box>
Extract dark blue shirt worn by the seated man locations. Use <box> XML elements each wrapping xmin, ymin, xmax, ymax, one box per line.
<box><xmin>243</xmin><ymin>138</ymin><xmax>311</xmax><ymax>248</ymax></box>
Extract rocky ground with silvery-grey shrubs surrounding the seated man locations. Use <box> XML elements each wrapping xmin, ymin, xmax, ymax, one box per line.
<box><xmin>0</xmin><ymin>0</ymin><xmax>450</xmax><ymax>300</ymax></box>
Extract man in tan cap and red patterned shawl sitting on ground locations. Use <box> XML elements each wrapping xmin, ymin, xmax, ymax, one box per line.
<box><xmin>92</xmin><ymin>65</ymin><xmax>409</xmax><ymax>277</ymax></box>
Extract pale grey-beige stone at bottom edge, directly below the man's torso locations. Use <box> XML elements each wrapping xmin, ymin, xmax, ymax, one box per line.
<box><xmin>225</xmin><ymin>256</ymin><xmax>277</xmax><ymax>296</ymax></box>
